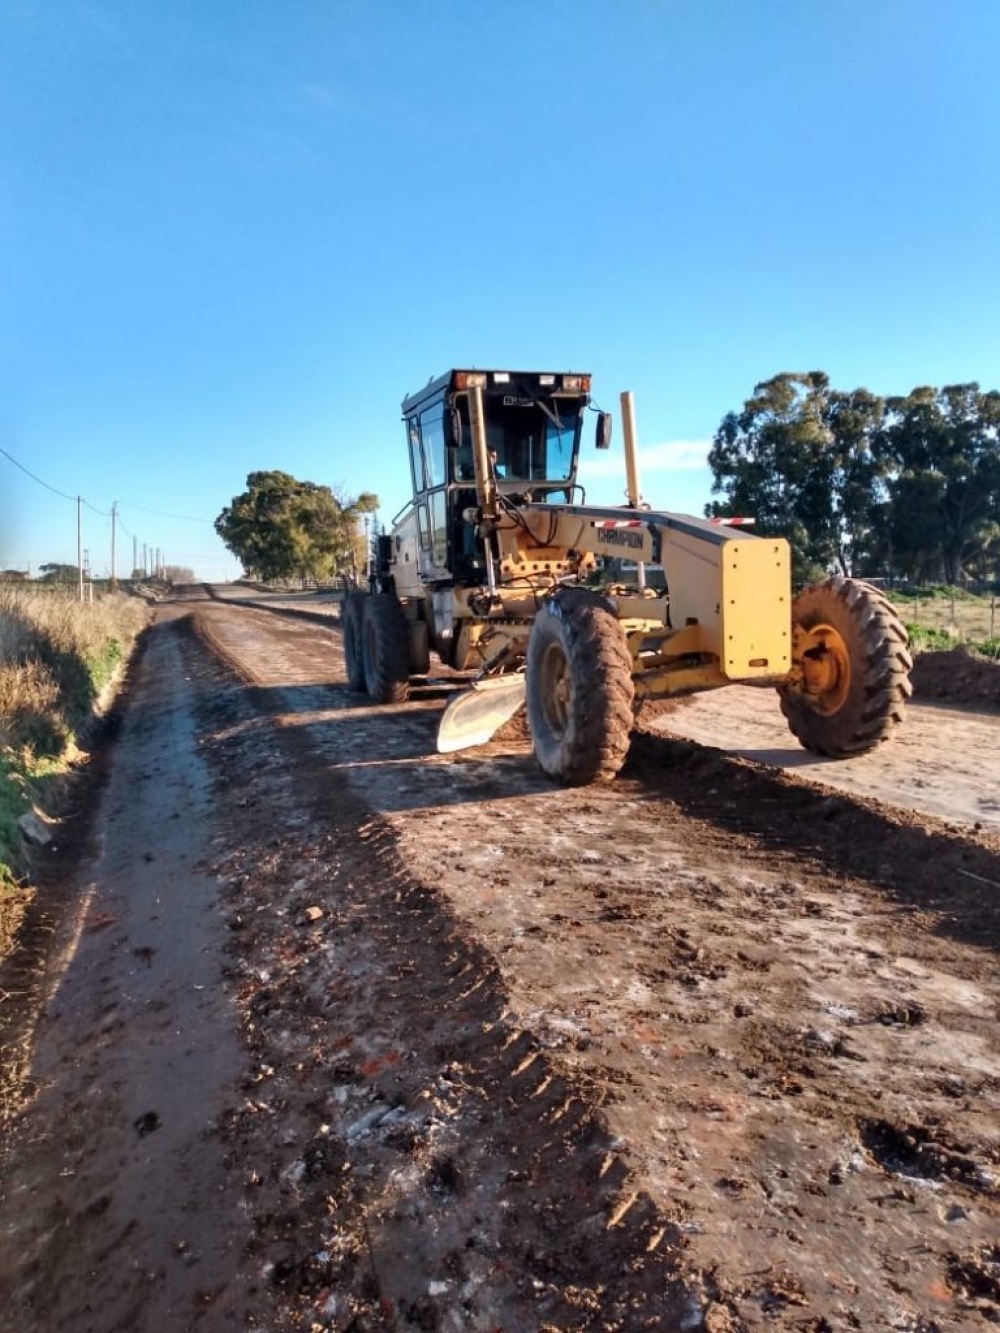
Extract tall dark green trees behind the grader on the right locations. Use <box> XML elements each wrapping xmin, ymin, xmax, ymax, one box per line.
<box><xmin>705</xmin><ymin>371</ymin><xmax>1000</xmax><ymax>584</ymax></box>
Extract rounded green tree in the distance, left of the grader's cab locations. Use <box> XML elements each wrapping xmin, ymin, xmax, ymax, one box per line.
<box><xmin>215</xmin><ymin>472</ymin><xmax>379</xmax><ymax>580</ymax></box>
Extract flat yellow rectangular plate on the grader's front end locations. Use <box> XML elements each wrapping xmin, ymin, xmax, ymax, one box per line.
<box><xmin>719</xmin><ymin>537</ymin><xmax>792</xmax><ymax>680</ymax></box>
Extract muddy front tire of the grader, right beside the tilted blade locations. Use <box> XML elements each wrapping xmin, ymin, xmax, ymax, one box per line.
<box><xmin>527</xmin><ymin>593</ymin><xmax>635</xmax><ymax>786</ymax></box>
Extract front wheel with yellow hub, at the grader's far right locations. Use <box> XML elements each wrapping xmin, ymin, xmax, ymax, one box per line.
<box><xmin>777</xmin><ymin>579</ymin><xmax>913</xmax><ymax>758</ymax></box>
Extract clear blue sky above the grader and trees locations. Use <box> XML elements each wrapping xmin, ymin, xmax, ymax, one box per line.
<box><xmin>0</xmin><ymin>0</ymin><xmax>1000</xmax><ymax>579</ymax></box>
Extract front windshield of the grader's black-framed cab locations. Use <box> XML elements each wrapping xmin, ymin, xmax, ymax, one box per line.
<box><xmin>485</xmin><ymin>396</ymin><xmax>580</xmax><ymax>483</ymax></box>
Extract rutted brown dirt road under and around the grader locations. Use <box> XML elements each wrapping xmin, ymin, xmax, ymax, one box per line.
<box><xmin>0</xmin><ymin>591</ymin><xmax>1000</xmax><ymax>1333</ymax></box>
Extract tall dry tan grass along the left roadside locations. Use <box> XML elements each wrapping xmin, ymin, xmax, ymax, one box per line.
<box><xmin>0</xmin><ymin>587</ymin><xmax>148</xmax><ymax>958</ymax></box>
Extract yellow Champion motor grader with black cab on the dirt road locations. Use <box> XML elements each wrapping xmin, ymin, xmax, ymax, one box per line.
<box><xmin>343</xmin><ymin>369</ymin><xmax>912</xmax><ymax>785</ymax></box>
